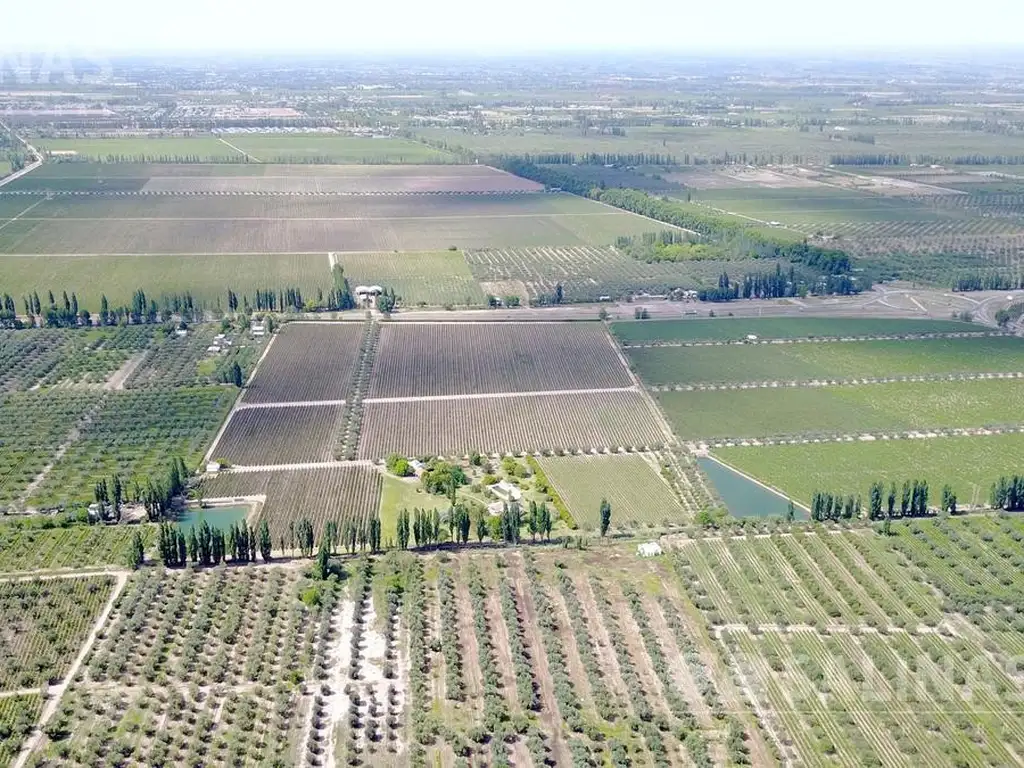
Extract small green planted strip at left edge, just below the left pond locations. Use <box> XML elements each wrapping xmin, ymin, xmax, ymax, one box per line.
<box><xmin>0</xmin><ymin>518</ymin><xmax>156</xmax><ymax>573</ymax></box>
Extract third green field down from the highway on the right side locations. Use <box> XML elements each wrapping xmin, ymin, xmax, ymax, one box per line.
<box><xmin>655</xmin><ymin>379</ymin><xmax>1024</xmax><ymax>439</ymax></box>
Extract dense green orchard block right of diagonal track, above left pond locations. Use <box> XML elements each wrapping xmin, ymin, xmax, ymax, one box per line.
<box><xmin>29</xmin><ymin>387</ymin><xmax>237</xmax><ymax>507</ymax></box>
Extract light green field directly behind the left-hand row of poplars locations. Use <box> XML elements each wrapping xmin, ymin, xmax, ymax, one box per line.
<box><xmin>0</xmin><ymin>253</ymin><xmax>331</xmax><ymax>312</ymax></box>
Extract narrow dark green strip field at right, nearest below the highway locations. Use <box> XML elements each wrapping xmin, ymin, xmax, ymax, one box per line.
<box><xmin>611</xmin><ymin>317</ymin><xmax>989</xmax><ymax>344</ymax></box>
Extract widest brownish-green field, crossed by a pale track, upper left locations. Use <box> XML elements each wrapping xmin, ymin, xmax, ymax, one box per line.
<box><xmin>0</xmin><ymin>195</ymin><xmax>651</xmax><ymax>255</ymax></box>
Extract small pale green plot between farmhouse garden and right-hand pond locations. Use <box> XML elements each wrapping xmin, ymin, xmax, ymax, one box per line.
<box><xmin>540</xmin><ymin>455</ymin><xmax>687</xmax><ymax>530</ymax></box>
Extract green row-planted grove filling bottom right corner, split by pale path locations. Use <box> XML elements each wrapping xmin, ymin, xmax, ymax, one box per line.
<box><xmin>673</xmin><ymin>516</ymin><xmax>1024</xmax><ymax>766</ymax></box>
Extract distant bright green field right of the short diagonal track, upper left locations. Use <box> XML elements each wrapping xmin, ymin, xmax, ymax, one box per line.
<box><xmin>224</xmin><ymin>133</ymin><xmax>457</xmax><ymax>165</ymax></box>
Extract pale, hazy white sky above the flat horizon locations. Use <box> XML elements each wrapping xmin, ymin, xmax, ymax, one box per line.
<box><xmin>6</xmin><ymin>0</ymin><xmax>1024</xmax><ymax>54</ymax></box>
